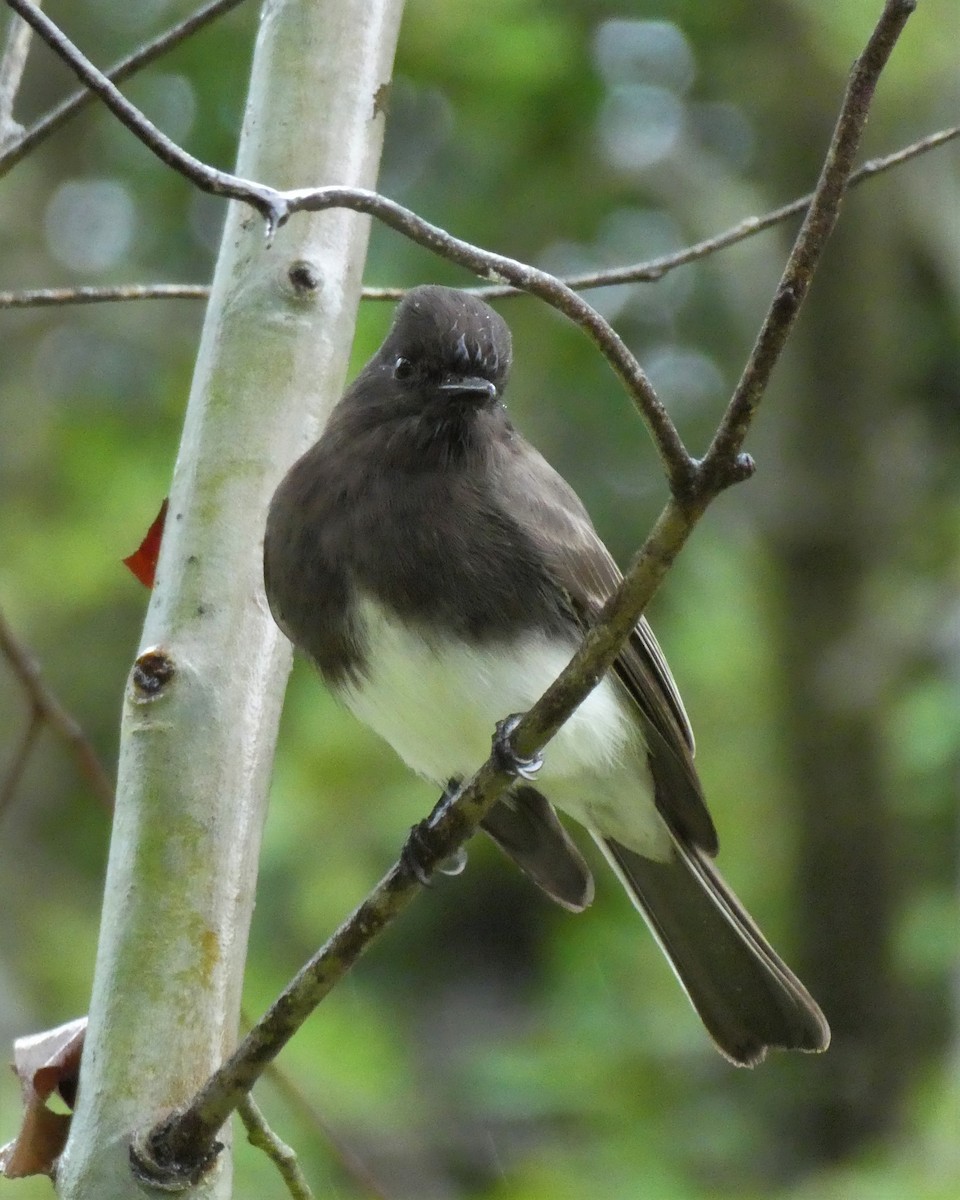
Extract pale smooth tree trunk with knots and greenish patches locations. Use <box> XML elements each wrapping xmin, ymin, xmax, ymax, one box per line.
<box><xmin>58</xmin><ymin>0</ymin><xmax>402</xmax><ymax>1200</ymax></box>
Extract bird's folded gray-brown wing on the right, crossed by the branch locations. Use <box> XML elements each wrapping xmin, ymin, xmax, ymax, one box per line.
<box><xmin>497</xmin><ymin>434</ymin><xmax>716</xmax><ymax>854</ymax></box>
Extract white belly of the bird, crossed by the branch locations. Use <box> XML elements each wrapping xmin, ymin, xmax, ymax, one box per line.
<box><xmin>340</xmin><ymin>599</ymin><xmax>668</xmax><ymax>857</ymax></box>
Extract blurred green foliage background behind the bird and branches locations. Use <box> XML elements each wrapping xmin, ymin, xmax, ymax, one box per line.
<box><xmin>0</xmin><ymin>0</ymin><xmax>960</xmax><ymax>1200</ymax></box>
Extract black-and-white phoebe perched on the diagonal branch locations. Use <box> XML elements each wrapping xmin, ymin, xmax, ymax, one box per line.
<box><xmin>264</xmin><ymin>287</ymin><xmax>829</xmax><ymax>1066</ymax></box>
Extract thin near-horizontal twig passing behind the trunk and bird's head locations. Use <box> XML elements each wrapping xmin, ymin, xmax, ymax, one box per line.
<box><xmin>0</xmin><ymin>125</ymin><xmax>960</xmax><ymax>308</ymax></box>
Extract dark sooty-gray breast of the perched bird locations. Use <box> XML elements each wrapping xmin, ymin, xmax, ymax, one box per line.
<box><xmin>264</xmin><ymin>412</ymin><xmax>572</xmax><ymax>685</ymax></box>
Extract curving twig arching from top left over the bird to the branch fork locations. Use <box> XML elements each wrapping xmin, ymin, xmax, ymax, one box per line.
<box><xmin>0</xmin><ymin>0</ymin><xmax>695</xmax><ymax>493</ymax></box>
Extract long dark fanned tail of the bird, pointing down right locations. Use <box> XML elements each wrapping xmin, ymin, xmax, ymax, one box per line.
<box><xmin>594</xmin><ymin>833</ymin><xmax>830</xmax><ymax>1067</ymax></box>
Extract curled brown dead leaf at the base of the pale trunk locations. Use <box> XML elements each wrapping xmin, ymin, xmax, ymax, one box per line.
<box><xmin>0</xmin><ymin>1016</ymin><xmax>86</xmax><ymax>1180</ymax></box>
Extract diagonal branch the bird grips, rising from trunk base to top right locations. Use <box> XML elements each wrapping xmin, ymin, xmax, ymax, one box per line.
<box><xmin>131</xmin><ymin>0</ymin><xmax>914</xmax><ymax>1187</ymax></box>
